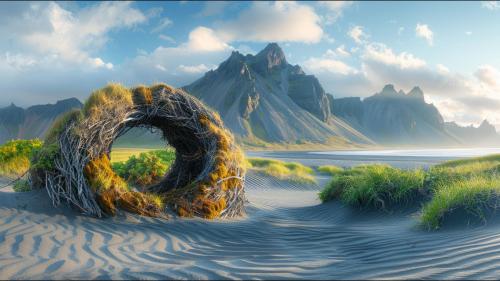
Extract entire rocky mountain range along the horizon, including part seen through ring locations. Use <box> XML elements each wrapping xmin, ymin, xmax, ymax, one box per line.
<box><xmin>0</xmin><ymin>43</ymin><xmax>500</xmax><ymax>146</ymax></box>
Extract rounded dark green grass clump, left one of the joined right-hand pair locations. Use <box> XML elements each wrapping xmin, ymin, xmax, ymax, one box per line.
<box><xmin>319</xmin><ymin>164</ymin><xmax>425</xmax><ymax>209</ymax></box>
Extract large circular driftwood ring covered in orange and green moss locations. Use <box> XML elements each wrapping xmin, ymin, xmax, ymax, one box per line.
<box><xmin>30</xmin><ymin>84</ymin><xmax>245</xmax><ymax>218</ymax></box>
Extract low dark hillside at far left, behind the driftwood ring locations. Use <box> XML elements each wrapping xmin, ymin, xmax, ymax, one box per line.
<box><xmin>0</xmin><ymin>98</ymin><xmax>82</xmax><ymax>143</ymax></box>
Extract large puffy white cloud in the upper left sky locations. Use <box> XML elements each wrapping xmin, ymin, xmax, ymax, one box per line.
<box><xmin>20</xmin><ymin>2</ymin><xmax>146</xmax><ymax>68</ymax></box>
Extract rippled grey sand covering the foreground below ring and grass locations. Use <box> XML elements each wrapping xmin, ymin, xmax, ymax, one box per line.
<box><xmin>0</xmin><ymin>173</ymin><xmax>500</xmax><ymax>279</ymax></box>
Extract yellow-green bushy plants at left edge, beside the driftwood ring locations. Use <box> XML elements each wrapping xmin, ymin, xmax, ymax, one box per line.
<box><xmin>0</xmin><ymin>139</ymin><xmax>42</xmax><ymax>178</ymax></box>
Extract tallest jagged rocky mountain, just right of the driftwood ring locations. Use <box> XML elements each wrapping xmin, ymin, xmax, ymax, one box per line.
<box><xmin>183</xmin><ymin>43</ymin><xmax>372</xmax><ymax>143</ymax></box>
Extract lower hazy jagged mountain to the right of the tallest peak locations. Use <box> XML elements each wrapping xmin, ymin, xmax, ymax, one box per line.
<box><xmin>329</xmin><ymin>84</ymin><xmax>498</xmax><ymax>145</ymax></box>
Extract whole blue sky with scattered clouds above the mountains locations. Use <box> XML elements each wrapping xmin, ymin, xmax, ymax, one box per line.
<box><xmin>0</xmin><ymin>1</ymin><xmax>500</xmax><ymax>129</ymax></box>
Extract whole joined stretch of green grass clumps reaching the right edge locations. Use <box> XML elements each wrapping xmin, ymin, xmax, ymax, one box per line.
<box><xmin>319</xmin><ymin>155</ymin><xmax>500</xmax><ymax>230</ymax></box>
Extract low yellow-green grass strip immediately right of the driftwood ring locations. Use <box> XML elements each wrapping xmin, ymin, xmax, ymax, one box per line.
<box><xmin>247</xmin><ymin>158</ymin><xmax>316</xmax><ymax>183</ymax></box>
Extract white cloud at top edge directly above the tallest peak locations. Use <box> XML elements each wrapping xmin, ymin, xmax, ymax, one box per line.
<box><xmin>214</xmin><ymin>1</ymin><xmax>323</xmax><ymax>43</ymax></box>
